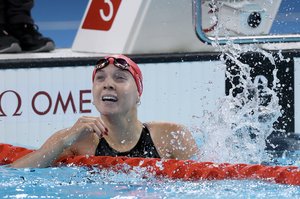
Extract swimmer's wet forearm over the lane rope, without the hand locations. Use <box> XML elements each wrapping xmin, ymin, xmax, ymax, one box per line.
<box><xmin>10</xmin><ymin>130</ymin><xmax>72</xmax><ymax>168</ymax></box>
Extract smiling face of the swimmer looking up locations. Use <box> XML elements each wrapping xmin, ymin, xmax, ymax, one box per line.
<box><xmin>93</xmin><ymin>64</ymin><xmax>138</xmax><ymax>115</ymax></box>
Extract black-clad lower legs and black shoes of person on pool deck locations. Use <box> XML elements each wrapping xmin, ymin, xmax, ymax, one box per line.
<box><xmin>0</xmin><ymin>0</ymin><xmax>55</xmax><ymax>53</ymax></box>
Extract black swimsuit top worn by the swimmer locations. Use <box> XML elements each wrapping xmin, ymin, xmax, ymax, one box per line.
<box><xmin>95</xmin><ymin>125</ymin><xmax>160</xmax><ymax>158</ymax></box>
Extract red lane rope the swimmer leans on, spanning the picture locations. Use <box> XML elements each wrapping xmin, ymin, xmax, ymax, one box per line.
<box><xmin>0</xmin><ymin>144</ymin><xmax>300</xmax><ymax>185</ymax></box>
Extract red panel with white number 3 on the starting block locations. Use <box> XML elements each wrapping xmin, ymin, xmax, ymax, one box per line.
<box><xmin>82</xmin><ymin>0</ymin><xmax>121</xmax><ymax>31</ymax></box>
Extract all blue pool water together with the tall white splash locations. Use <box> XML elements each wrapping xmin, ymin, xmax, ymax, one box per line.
<box><xmin>0</xmin><ymin>44</ymin><xmax>300</xmax><ymax>199</ymax></box>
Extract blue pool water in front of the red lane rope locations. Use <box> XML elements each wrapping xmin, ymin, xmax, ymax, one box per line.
<box><xmin>0</xmin><ymin>157</ymin><xmax>300</xmax><ymax>199</ymax></box>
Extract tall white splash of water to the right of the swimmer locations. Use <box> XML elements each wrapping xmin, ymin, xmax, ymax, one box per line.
<box><xmin>196</xmin><ymin>1</ymin><xmax>283</xmax><ymax>163</ymax></box>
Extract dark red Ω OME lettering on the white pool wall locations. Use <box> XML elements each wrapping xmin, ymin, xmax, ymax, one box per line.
<box><xmin>0</xmin><ymin>90</ymin><xmax>92</xmax><ymax>117</ymax></box>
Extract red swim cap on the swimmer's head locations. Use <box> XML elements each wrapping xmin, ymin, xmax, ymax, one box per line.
<box><xmin>92</xmin><ymin>55</ymin><xmax>143</xmax><ymax>96</ymax></box>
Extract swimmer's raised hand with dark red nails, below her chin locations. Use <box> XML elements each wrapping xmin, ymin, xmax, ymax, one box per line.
<box><xmin>63</xmin><ymin>116</ymin><xmax>108</xmax><ymax>147</ymax></box>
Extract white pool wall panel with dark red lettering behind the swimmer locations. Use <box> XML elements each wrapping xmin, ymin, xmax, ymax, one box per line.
<box><xmin>0</xmin><ymin>61</ymin><xmax>225</xmax><ymax>147</ymax></box>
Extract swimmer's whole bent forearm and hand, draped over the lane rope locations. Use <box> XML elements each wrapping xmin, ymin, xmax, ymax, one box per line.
<box><xmin>11</xmin><ymin>116</ymin><xmax>108</xmax><ymax>168</ymax></box>
